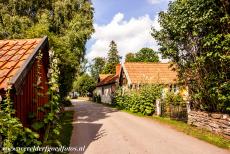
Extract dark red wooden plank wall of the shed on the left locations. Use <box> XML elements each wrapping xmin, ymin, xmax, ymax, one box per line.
<box><xmin>13</xmin><ymin>57</ymin><xmax>48</xmax><ymax>127</ymax></box>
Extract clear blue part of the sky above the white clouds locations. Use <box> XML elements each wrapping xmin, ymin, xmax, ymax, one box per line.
<box><xmin>92</xmin><ymin>0</ymin><xmax>168</xmax><ymax>25</ymax></box>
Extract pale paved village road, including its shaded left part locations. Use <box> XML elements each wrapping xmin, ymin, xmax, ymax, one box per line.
<box><xmin>68</xmin><ymin>100</ymin><xmax>230</xmax><ymax>154</ymax></box>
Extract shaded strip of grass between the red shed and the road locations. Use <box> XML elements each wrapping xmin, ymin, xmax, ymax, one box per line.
<box><xmin>59</xmin><ymin>111</ymin><xmax>74</xmax><ymax>147</ymax></box>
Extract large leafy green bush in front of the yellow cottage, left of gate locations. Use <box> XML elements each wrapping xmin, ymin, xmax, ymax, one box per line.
<box><xmin>115</xmin><ymin>85</ymin><xmax>162</xmax><ymax>115</ymax></box>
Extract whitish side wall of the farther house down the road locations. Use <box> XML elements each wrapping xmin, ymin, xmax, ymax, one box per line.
<box><xmin>95</xmin><ymin>84</ymin><xmax>115</xmax><ymax>104</ymax></box>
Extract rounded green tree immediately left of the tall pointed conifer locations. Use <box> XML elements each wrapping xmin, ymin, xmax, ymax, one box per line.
<box><xmin>90</xmin><ymin>57</ymin><xmax>105</xmax><ymax>79</ymax></box>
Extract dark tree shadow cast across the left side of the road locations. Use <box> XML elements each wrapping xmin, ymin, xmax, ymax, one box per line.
<box><xmin>68</xmin><ymin>101</ymin><xmax>118</xmax><ymax>154</ymax></box>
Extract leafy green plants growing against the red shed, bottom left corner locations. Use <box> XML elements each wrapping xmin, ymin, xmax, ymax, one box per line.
<box><xmin>0</xmin><ymin>88</ymin><xmax>42</xmax><ymax>153</ymax></box>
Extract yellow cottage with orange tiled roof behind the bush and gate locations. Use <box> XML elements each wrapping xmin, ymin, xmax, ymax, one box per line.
<box><xmin>119</xmin><ymin>62</ymin><xmax>188</xmax><ymax>95</ymax></box>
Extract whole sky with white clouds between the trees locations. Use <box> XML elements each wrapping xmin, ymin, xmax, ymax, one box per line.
<box><xmin>86</xmin><ymin>0</ymin><xmax>169</xmax><ymax>61</ymax></box>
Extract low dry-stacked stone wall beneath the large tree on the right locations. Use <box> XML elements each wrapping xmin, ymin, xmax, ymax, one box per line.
<box><xmin>188</xmin><ymin>111</ymin><xmax>230</xmax><ymax>137</ymax></box>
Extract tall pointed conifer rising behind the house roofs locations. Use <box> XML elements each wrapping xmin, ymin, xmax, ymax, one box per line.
<box><xmin>103</xmin><ymin>41</ymin><xmax>120</xmax><ymax>74</ymax></box>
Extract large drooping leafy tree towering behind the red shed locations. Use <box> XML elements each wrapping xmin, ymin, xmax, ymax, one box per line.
<box><xmin>0</xmin><ymin>0</ymin><xmax>94</xmax><ymax>98</ymax></box>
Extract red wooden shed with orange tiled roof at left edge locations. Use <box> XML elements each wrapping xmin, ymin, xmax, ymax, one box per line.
<box><xmin>0</xmin><ymin>37</ymin><xmax>49</xmax><ymax>127</ymax></box>
